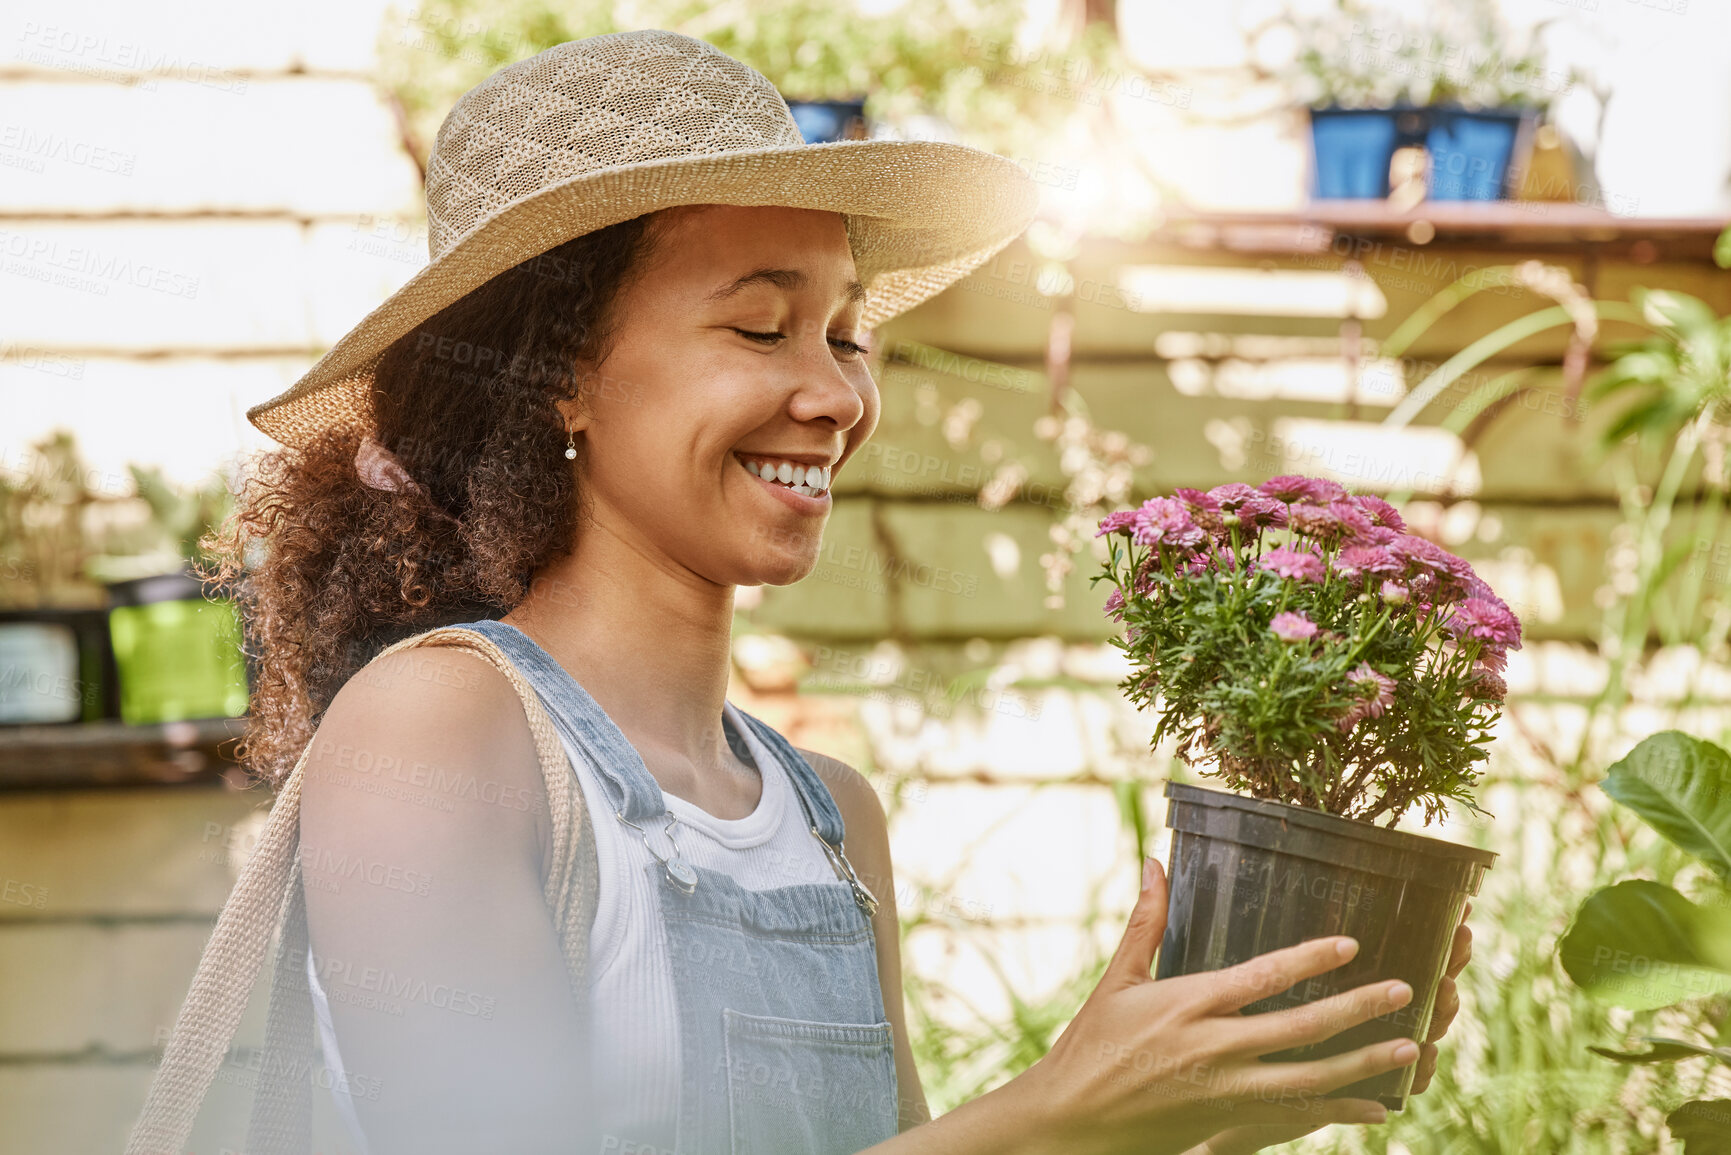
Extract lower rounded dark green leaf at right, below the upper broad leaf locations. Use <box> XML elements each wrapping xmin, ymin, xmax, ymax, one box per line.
<box><xmin>1556</xmin><ymin>878</ymin><xmax>1731</xmax><ymax>1011</ymax></box>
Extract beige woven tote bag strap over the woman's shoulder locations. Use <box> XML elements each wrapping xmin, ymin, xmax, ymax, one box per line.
<box><xmin>126</xmin><ymin>625</ymin><xmax>597</xmax><ymax>1155</ymax></box>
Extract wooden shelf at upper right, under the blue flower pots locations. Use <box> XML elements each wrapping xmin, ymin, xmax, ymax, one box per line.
<box><xmin>1155</xmin><ymin>201</ymin><xmax>1728</xmax><ymax>265</ymax></box>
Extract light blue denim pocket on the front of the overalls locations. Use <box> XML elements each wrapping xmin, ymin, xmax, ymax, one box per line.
<box><xmin>722</xmin><ymin>1008</ymin><xmax>897</xmax><ymax>1155</ymax></box>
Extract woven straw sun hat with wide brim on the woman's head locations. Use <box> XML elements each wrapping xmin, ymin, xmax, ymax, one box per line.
<box><xmin>246</xmin><ymin>29</ymin><xmax>1039</xmax><ymax>447</ymax></box>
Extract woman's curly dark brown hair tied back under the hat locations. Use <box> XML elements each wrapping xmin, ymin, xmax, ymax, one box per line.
<box><xmin>203</xmin><ymin>210</ymin><xmax>666</xmax><ymax>788</ymax></box>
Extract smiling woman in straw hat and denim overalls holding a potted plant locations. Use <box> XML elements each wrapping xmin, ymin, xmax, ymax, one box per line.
<box><xmin>189</xmin><ymin>31</ymin><xmax>1466</xmax><ymax>1155</ymax></box>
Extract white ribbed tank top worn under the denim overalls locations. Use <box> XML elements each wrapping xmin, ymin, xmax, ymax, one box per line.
<box><xmin>306</xmin><ymin>701</ymin><xmax>855</xmax><ymax>1155</ymax></box>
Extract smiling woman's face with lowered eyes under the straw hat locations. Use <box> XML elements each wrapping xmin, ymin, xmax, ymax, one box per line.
<box><xmin>568</xmin><ymin>204</ymin><xmax>878</xmax><ymax>585</ymax></box>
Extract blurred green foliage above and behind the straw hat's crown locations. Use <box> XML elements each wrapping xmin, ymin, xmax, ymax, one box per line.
<box><xmin>381</xmin><ymin>0</ymin><xmax>1136</xmax><ymax>171</ymax></box>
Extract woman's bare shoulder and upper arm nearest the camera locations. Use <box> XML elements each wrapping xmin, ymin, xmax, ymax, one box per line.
<box><xmin>301</xmin><ymin>648</ymin><xmax>585</xmax><ymax>1155</ymax></box>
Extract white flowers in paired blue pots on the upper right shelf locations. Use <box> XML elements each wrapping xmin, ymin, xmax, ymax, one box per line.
<box><xmin>1295</xmin><ymin>0</ymin><xmax>1573</xmax><ymax>201</ymax></box>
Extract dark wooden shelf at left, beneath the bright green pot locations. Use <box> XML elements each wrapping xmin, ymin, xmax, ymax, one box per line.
<box><xmin>0</xmin><ymin>717</ymin><xmax>249</xmax><ymax>791</ymax></box>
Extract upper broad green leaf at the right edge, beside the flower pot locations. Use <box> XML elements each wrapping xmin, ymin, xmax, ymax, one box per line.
<box><xmin>1599</xmin><ymin>731</ymin><xmax>1731</xmax><ymax>880</ymax></box>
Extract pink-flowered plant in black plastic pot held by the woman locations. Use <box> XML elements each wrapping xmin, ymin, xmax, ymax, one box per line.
<box><xmin>1094</xmin><ymin>476</ymin><xmax>1522</xmax><ymax>1110</ymax></box>
